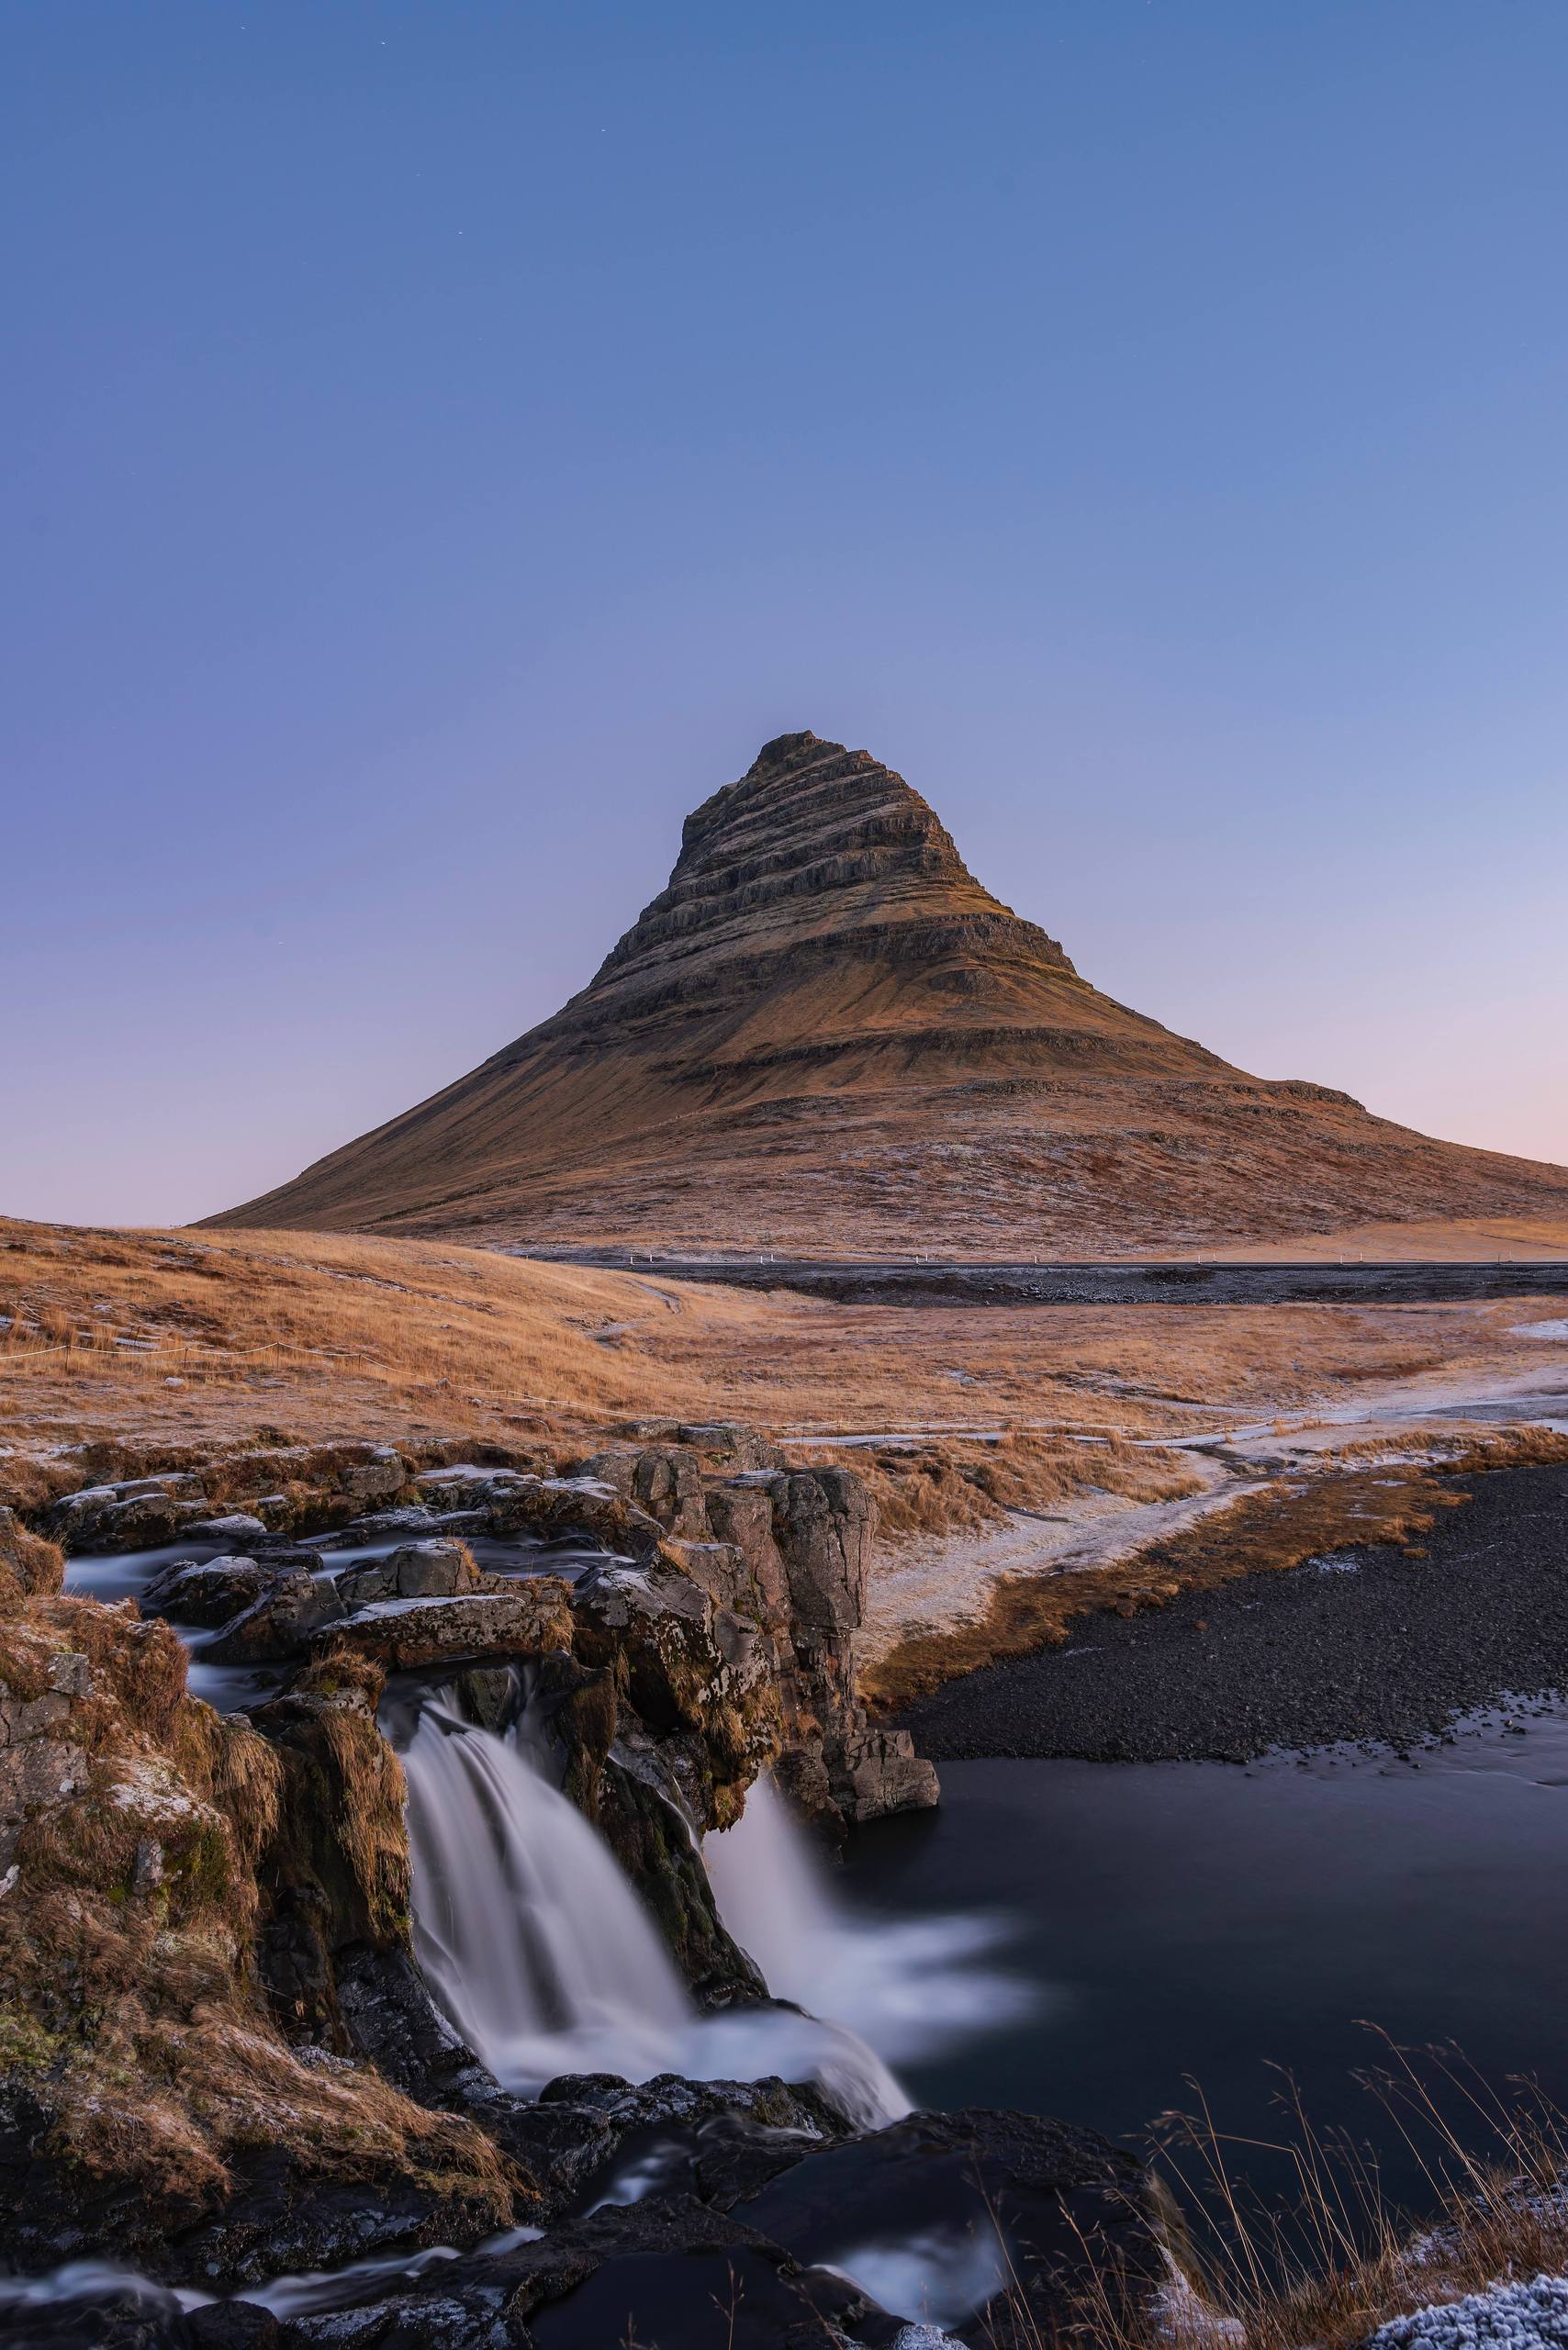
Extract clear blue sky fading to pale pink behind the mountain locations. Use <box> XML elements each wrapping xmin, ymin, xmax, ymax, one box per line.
<box><xmin>0</xmin><ymin>0</ymin><xmax>1568</xmax><ymax>1222</ymax></box>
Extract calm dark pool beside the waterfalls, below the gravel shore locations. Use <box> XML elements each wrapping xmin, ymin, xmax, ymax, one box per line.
<box><xmin>842</xmin><ymin>1708</ymin><xmax>1568</xmax><ymax>2202</ymax></box>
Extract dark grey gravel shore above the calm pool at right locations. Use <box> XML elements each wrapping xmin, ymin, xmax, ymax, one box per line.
<box><xmin>901</xmin><ymin>1469</ymin><xmax>1568</xmax><ymax>1762</ymax></box>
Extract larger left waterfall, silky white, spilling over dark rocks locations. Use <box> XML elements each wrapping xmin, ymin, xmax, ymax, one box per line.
<box><xmin>402</xmin><ymin>1699</ymin><xmax>910</xmax><ymax>2127</ymax></box>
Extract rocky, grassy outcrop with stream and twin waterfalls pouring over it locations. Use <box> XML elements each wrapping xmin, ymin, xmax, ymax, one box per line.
<box><xmin>0</xmin><ymin>1427</ymin><xmax>1170</xmax><ymax>2350</ymax></box>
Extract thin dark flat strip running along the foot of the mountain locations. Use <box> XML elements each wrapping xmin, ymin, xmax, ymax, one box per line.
<box><xmin>517</xmin><ymin>1248</ymin><xmax>1568</xmax><ymax>1306</ymax></box>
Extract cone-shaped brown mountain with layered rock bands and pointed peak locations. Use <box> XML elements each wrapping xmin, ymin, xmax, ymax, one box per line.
<box><xmin>211</xmin><ymin>733</ymin><xmax>1568</xmax><ymax>1255</ymax></box>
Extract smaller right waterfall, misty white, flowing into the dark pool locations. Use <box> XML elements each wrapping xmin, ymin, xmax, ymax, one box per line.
<box><xmin>703</xmin><ymin>1779</ymin><xmax>1036</xmax><ymax>2064</ymax></box>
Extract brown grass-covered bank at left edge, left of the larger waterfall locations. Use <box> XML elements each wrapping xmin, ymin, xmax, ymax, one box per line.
<box><xmin>0</xmin><ymin>1598</ymin><xmax>524</xmax><ymax>2230</ymax></box>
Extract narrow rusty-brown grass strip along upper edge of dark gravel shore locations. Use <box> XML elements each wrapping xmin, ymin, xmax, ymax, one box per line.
<box><xmin>860</xmin><ymin>1469</ymin><xmax>1467</xmax><ymax>1711</ymax></box>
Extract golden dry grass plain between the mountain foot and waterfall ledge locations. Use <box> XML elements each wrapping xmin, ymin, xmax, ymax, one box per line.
<box><xmin>0</xmin><ymin>1222</ymin><xmax>1542</xmax><ymax>1535</ymax></box>
